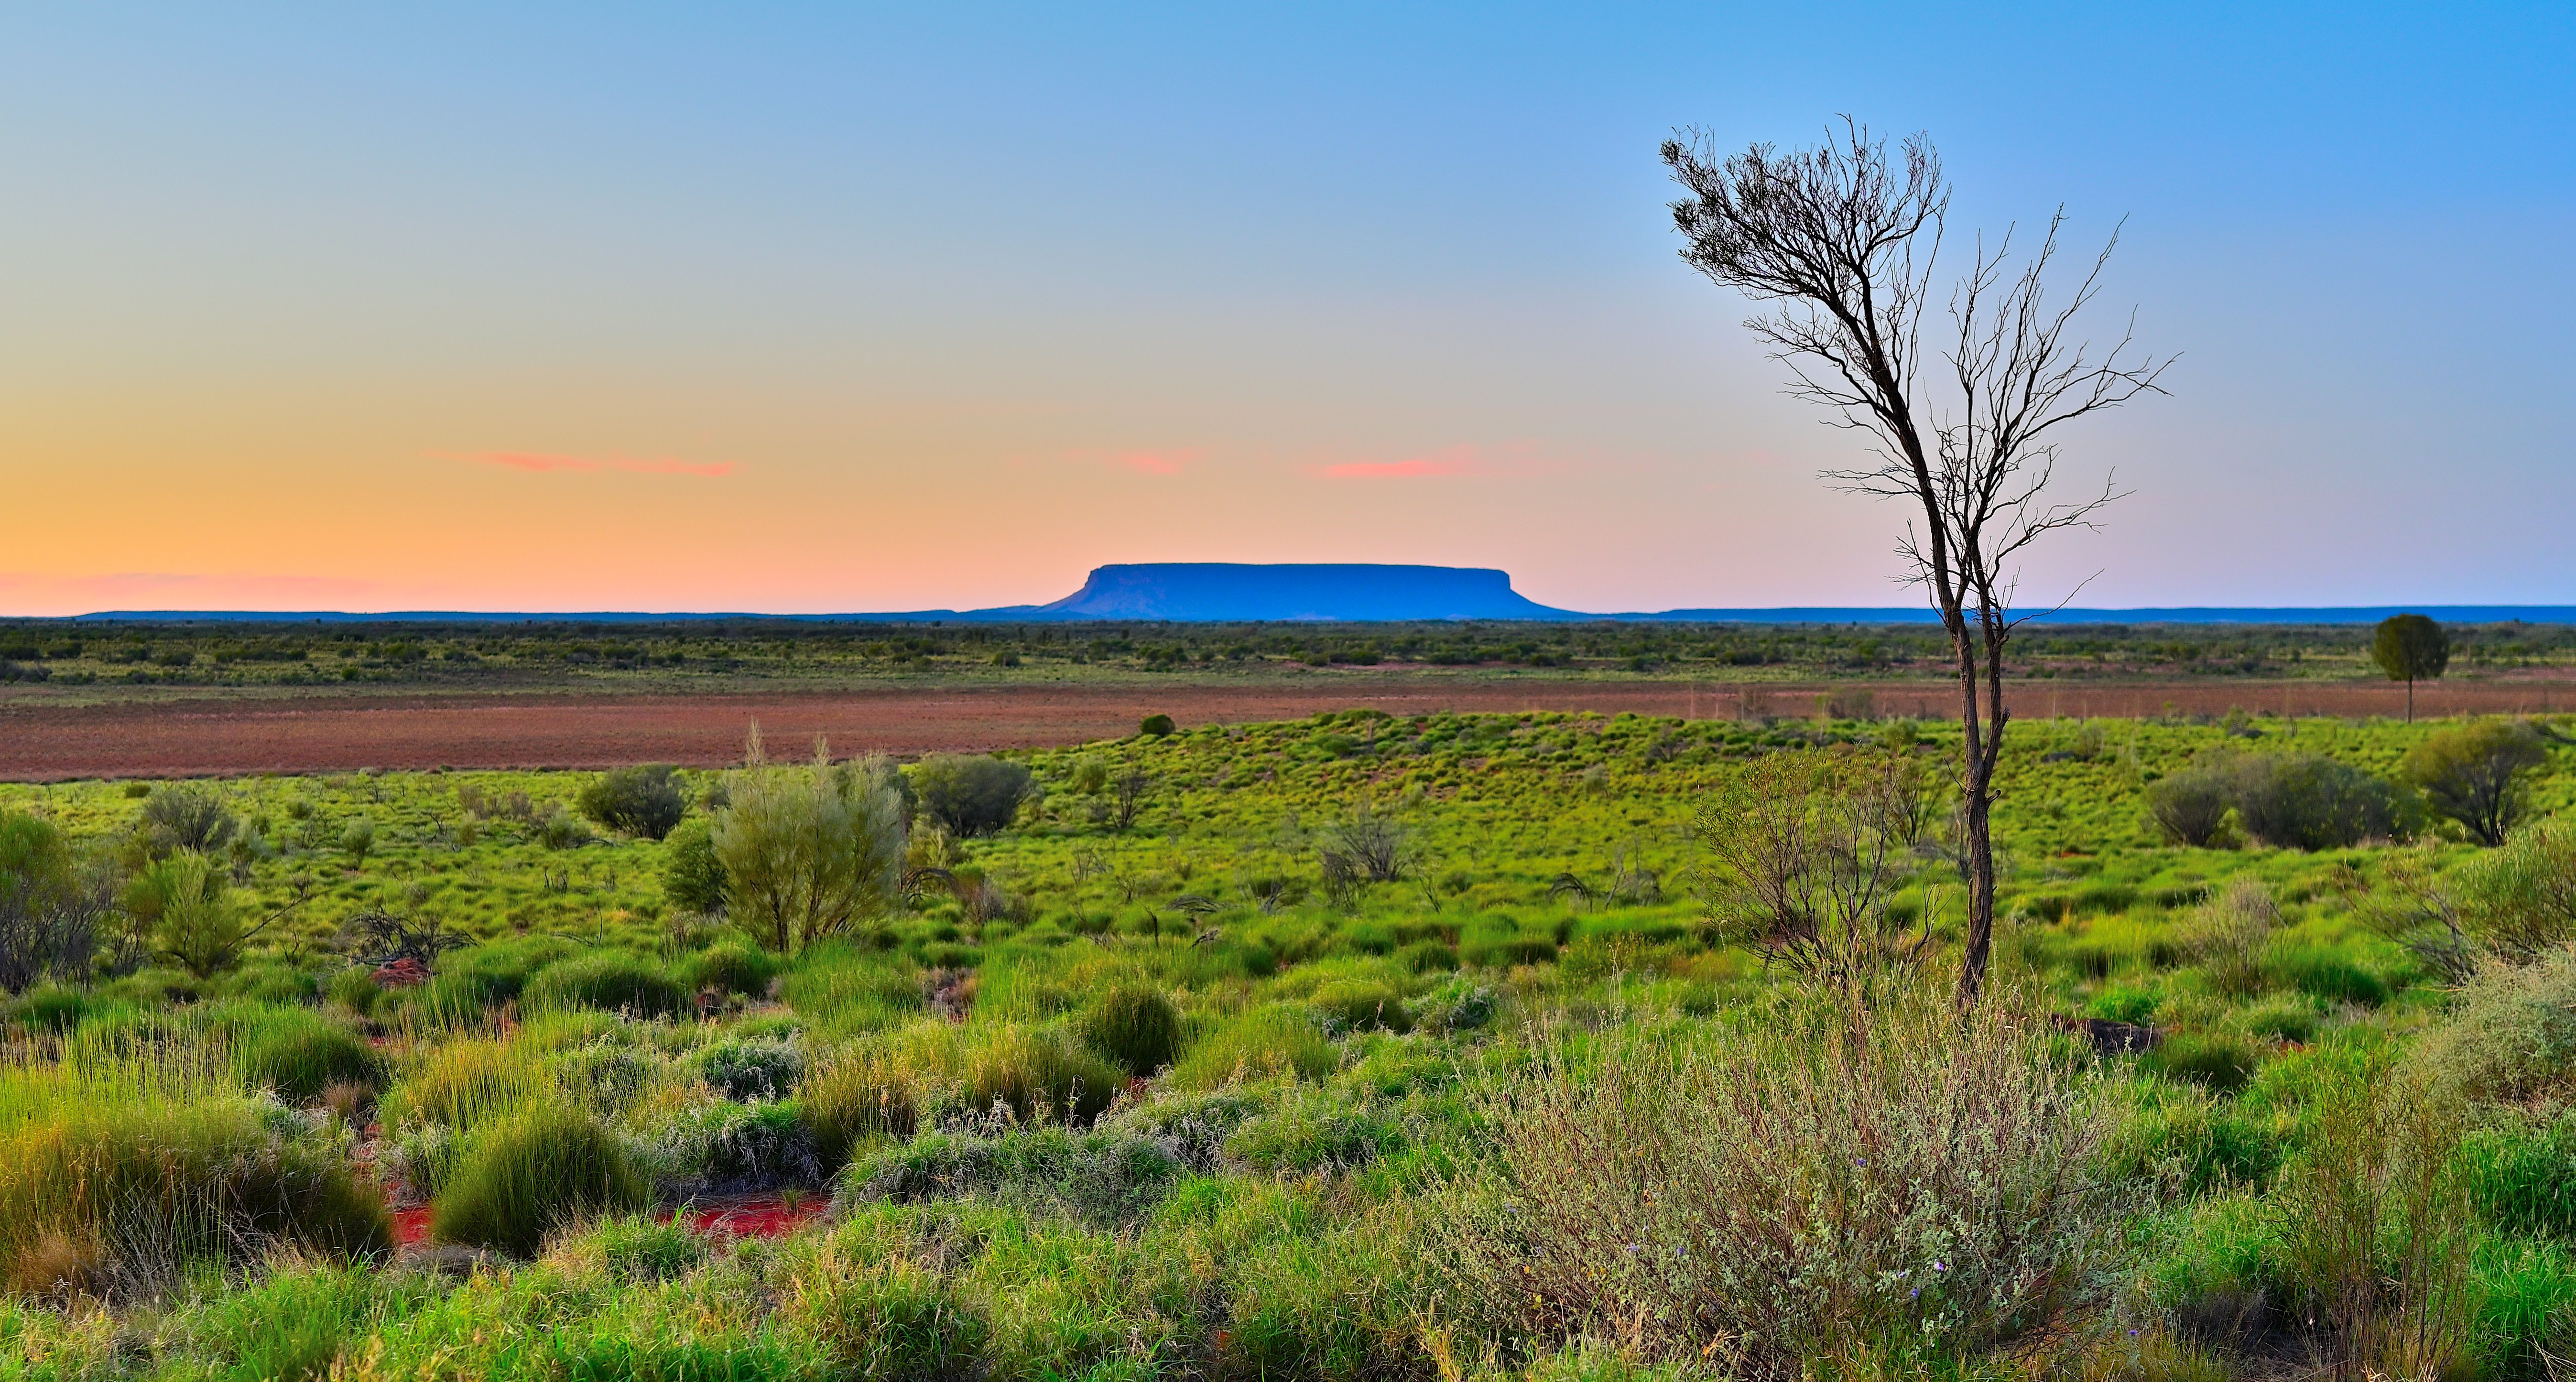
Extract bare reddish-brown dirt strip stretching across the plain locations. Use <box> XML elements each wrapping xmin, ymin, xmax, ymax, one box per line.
<box><xmin>0</xmin><ymin>672</ymin><xmax>2576</xmax><ymax>782</ymax></box>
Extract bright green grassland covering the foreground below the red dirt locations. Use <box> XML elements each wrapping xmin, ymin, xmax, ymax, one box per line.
<box><xmin>0</xmin><ymin>705</ymin><xmax>2576</xmax><ymax>1380</ymax></box>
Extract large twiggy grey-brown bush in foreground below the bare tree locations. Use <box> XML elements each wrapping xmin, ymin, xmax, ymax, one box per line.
<box><xmin>1432</xmin><ymin>996</ymin><xmax>2120</xmax><ymax>1377</ymax></box>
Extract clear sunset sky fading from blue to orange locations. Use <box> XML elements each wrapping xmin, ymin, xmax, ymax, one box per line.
<box><xmin>0</xmin><ymin>2</ymin><xmax>2576</xmax><ymax>615</ymax></box>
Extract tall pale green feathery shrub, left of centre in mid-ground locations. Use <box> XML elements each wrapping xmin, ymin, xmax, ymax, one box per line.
<box><xmin>714</xmin><ymin>736</ymin><xmax>904</xmax><ymax>955</ymax></box>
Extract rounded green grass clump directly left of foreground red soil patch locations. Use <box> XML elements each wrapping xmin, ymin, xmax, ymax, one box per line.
<box><xmin>430</xmin><ymin>1101</ymin><xmax>652</xmax><ymax>1258</ymax></box>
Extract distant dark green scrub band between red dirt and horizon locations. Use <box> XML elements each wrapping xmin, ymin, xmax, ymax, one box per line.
<box><xmin>0</xmin><ymin>620</ymin><xmax>2576</xmax><ymax>697</ymax></box>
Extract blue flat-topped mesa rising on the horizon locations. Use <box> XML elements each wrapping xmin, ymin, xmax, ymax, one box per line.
<box><xmin>1035</xmin><ymin>561</ymin><xmax>1584</xmax><ymax>620</ymax></box>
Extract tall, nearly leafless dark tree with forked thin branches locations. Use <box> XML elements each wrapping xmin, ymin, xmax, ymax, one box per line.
<box><xmin>1664</xmin><ymin>119</ymin><xmax>2172</xmax><ymax>1004</ymax></box>
